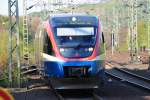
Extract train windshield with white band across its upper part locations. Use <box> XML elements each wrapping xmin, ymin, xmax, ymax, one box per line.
<box><xmin>55</xmin><ymin>27</ymin><xmax>97</xmax><ymax>47</ymax></box>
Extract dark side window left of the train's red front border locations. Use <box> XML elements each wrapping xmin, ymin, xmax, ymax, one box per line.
<box><xmin>43</xmin><ymin>32</ymin><xmax>52</xmax><ymax>55</ymax></box>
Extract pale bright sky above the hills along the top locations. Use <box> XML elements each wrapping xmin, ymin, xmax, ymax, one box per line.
<box><xmin>0</xmin><ymin>0</ymin><xmax>100</xmax><ymax>16</ymax></box>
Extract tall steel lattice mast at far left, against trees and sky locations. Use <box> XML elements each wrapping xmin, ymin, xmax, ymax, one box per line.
<box><xmin>8</xmin><ymin>0</ymin><xmax>20</xmax><ymax>87</ymax></box>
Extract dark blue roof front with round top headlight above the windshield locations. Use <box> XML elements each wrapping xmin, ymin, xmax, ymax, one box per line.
<box><xmin>48</xmin><ymin>14</ymin><xmax>99</xmax><ymax>27</ymax></box>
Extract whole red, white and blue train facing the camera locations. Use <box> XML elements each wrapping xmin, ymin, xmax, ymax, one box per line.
<box><xmin>36</xmin><ymin>14</ymin><xmax>104</xmax><ymax>89</ymax></box>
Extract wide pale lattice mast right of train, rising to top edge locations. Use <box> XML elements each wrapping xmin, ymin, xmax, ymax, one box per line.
<box><xmin>128</xmin><ymin>0</ymin><xmax>139</xmax><ymax>63</ymax></box>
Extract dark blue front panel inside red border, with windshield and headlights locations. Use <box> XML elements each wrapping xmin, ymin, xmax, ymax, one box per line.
<box><xmin>50</xmin><ymin>16</ymin><xmax>99</xmax><ymax>58</ymax></box>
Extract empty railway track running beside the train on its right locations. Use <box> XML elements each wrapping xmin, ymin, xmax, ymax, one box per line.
<box><xmin>105</xmin><ymin>62</ymin><xmax>150</xmax><ymax>91</ymax></box>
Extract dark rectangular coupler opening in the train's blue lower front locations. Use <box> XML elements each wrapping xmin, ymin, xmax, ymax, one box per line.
<box><xmin>63</xmin><ymin>66</ymin><xmax>89</xmax><ymax>78</ymax></box>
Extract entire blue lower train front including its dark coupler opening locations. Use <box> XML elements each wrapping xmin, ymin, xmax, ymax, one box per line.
<box><xmin>43</xmin><ymin>60</ymin><xmax>104</xmax><ymax>78</ymax></box>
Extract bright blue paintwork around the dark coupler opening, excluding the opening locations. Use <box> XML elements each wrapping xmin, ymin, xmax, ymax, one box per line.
<box><xmin>43</xmin><ymin>61</ymin><xmax>103</xmax><ymax>77</ymax></box>
